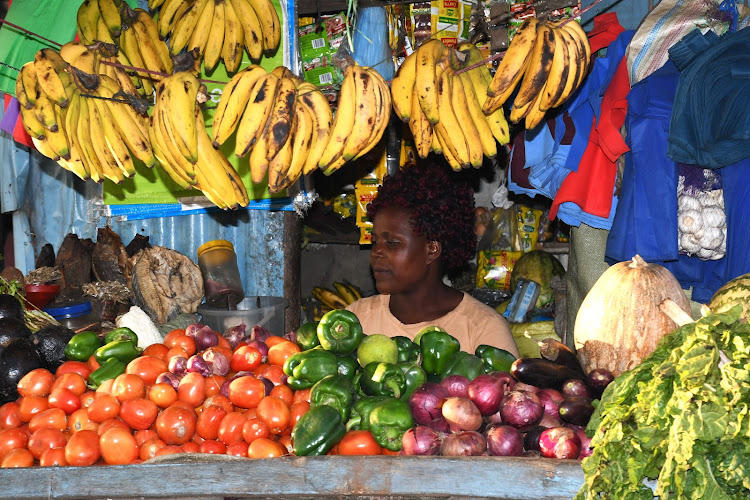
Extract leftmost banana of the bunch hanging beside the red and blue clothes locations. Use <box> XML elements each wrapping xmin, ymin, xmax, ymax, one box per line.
<box><xmin>482</xmin><ymin>17</ymin><xmax>539</xmax><ymax>114</ymax></box>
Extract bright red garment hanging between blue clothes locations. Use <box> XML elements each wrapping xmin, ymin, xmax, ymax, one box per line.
<box><xmin>549</xmin><ymin>58</ymin><xmax>630</xmax><ymax>219</ymax></box>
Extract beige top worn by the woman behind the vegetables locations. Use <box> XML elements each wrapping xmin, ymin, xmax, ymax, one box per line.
<box><xmin>347</xmin><ymin>293</ymin><xmax>518</xmax><ymax>357</ymax></box>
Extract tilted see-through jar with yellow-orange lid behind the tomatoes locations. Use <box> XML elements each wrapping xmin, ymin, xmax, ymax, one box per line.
<box><xmin>198</xmin><ymin>240</ymin><xmax>245</xmax><ymax>309</ymax></box>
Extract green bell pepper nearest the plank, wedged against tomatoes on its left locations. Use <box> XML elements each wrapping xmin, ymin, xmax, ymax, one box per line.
<box><xmin>292</xmin><ymin>405</ymin><xmax>346</xmax><ymax>457</ymax></box>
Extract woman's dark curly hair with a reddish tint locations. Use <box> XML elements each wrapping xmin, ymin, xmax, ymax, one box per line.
<box><xmin>367</xmin><ymin>161</ymin><xmax>476</xmax><ymax>272</ymax></box>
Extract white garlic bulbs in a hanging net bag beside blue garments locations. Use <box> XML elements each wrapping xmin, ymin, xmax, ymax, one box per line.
<box><xmin>677</xmin><ymin>189</ymin><xmax>727</xmax><ymax>260</ymax></box>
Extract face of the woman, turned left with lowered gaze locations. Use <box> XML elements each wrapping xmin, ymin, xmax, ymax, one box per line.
<box><xmin>370</xmin><ymin>207</ymin><xmax>439</xmax><ymax>295</ymax></box>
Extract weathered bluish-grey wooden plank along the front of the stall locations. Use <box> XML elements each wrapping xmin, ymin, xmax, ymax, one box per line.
<box><xmin>0</xmin><ymin>455</ymin><xmax>583</xmax><ymax>500</ymax></box>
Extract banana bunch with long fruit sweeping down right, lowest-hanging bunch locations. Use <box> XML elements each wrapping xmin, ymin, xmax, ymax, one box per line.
<box><xmin>148</xmin><ymin>71</ymin><xmax>249</xmax><ymax>209</ymax></box>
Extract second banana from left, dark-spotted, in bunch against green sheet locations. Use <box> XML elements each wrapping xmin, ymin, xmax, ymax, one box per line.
<box><xmin>234</xmin><ymin>73</ymin><xmax>279</xmax><ymax>157</ymax></box>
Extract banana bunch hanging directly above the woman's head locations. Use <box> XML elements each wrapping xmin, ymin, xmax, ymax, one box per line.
<box><xmin>391</xmin><ymin>39</ymin><xmax>510</xmax><ymax>170</ymax></box>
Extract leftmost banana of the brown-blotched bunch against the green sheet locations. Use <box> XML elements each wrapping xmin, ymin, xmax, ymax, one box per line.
<box><xmin>211</xmin><ymin>64</ymin><xmax>266</xmax><ymax>148</ymax></box>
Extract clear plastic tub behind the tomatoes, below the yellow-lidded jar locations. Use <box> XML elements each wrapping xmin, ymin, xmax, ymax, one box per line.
<box><xmin>198</xmin><ymin>296</ymin><xmax>289</xmax><ymax>335</ymax></box>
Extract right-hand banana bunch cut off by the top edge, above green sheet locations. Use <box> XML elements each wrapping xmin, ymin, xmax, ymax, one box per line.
<box><xmin>156</xmin><ymin>0</ymin><xmax>281</xmax><ymax>73</ymax></box>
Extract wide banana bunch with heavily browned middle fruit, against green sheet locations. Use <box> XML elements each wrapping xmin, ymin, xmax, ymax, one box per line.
<box><xmin>212</xmin><ymin>64</ymin><xmax>333</xmax><ymax>193</ymax></box>
